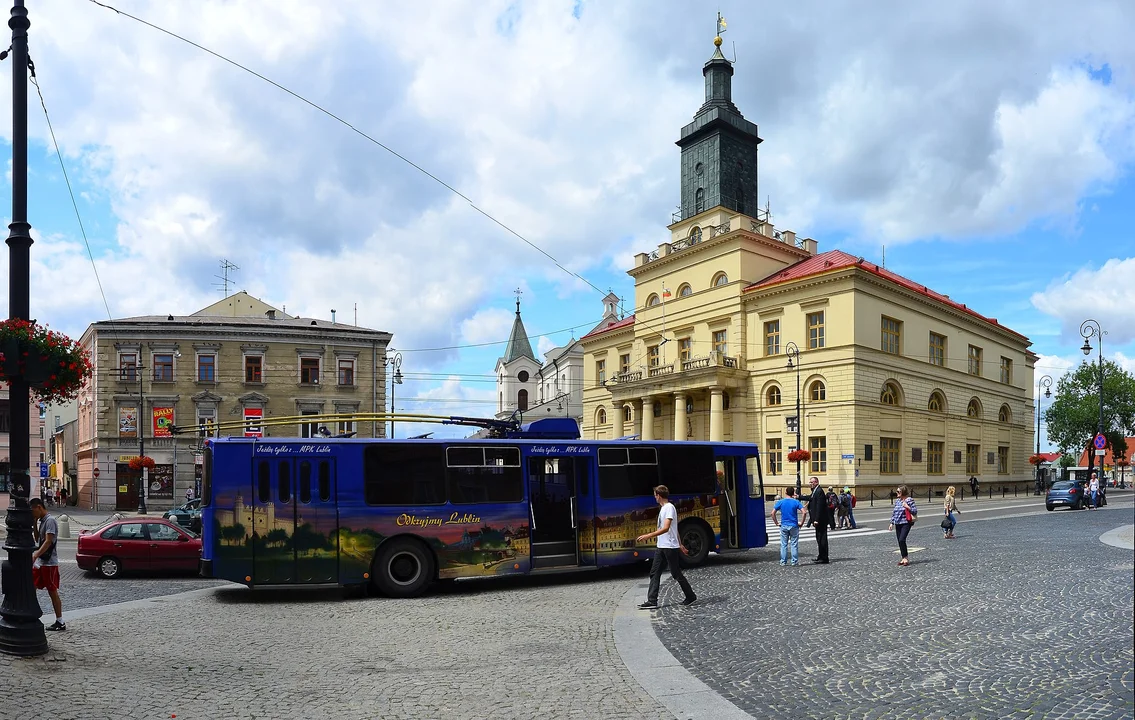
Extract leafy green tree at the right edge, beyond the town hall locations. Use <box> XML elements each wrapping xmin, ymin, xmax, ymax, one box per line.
<box><xmin>1044</xmin><ymin>360</ymin><xmax>1135</xmax><ymax>459</ymax></box>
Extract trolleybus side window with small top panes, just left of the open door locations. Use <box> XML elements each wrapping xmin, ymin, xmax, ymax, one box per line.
<box><xmin>446</xmin><ymin>447</ymin><xmax>524</xmax><ymax>504</ymax></box>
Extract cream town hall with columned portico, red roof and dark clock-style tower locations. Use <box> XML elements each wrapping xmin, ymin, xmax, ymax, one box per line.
<box><xmin>582</xmin><ymin>36</ymin><xmax>1036</xmax><ymax>496</ymax></box>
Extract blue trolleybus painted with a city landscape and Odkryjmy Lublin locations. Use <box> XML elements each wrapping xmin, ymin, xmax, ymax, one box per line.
<box><xmin>201</xmin><ymin>419</ymin><xmax>768</xmax><ymax>597</ymax></box>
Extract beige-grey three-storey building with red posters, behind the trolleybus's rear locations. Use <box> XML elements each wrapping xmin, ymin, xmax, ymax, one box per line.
<box><xmin>76</xmin><ymin>292</ymin><xmax>390</xmax><ymax>512</ymax></box>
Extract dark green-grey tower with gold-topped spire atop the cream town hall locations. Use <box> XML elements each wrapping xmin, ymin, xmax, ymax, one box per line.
<box><xmin>678</xmin><ymin>22</ymin><xmax>762</xmax><ymax>220</ymax></box>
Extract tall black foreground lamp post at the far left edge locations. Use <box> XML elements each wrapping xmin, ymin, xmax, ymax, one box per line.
<box><xmin>0</xmin><ymin>0</ymin><xmax>48</xmax><ymax>656</ymax></box>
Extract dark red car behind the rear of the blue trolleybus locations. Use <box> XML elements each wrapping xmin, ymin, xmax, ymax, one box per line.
<box><xmin>75</xmin><ymin>518</ymin><xmax>201</xmax><ymax>578</ymax></box>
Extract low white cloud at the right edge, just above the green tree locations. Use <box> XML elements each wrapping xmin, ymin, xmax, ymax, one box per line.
<box><xmin>1032</xmin><ymin>258</ymin><xmax>1135</xmax><ymax>345</ymax></box>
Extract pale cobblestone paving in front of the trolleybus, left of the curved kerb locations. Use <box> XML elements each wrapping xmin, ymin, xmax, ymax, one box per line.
<box><xmin>0</xmin><ymin>566</ymin><xmax>673</xmax><ymax>720</ymax></box>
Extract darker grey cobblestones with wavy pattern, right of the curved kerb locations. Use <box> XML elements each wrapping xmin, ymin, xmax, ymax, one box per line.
<box><xmin>655</xmin><ymin>503</ymin><xmax>1135</xmax><ymax>720</ymax></box>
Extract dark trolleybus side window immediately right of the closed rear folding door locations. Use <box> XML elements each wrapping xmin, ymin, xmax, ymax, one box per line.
<box><xmin>367</xmin><ymin>443</ymin><xmax>445</xmax><ymax>505</ymax></box>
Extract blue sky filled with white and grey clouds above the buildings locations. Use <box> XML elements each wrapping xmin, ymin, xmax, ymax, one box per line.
<box><xmin>0</xmin><ymin>0</ymin><xmax>1135</xmax><ymax>434</ymax></box>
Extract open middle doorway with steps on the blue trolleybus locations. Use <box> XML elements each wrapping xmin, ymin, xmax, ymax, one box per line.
<box><xmin>528</xmin><ymin>457</ymin><xmax>594</xmax><ymax>570</ymax></box>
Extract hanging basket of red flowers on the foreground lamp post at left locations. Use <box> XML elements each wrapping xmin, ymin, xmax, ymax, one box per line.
<box><xmin>0</xmin><ymin>319</ymin><xmax>93</xmax><ymax>403</ymax></box>
